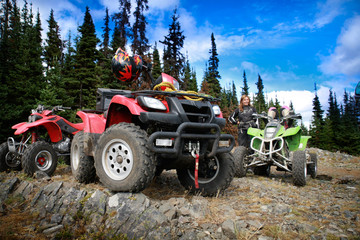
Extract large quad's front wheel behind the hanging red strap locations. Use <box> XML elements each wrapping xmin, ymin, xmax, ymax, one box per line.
<box><xmin>176</xmin><ymin>153</ymin><xmax>235</xmax><ymax>196</ymax></box>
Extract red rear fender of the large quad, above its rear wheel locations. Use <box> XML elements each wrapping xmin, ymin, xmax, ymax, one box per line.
<box><xmin>76</xmin><ymin>111</ymin><xmax>106</xmax><ymax>134</ymax></box>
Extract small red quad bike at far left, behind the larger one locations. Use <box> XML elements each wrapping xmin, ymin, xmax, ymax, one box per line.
<box><xmin>0</xmin><ymin>105</ymin><xmax>105</xmax><ymax>176</ymax></box>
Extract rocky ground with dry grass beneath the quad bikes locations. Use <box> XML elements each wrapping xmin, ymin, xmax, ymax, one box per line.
<box><xmin>0</xmin><ymin>149</ymin><xmax>360</xmax><ymax>240</ymax></box>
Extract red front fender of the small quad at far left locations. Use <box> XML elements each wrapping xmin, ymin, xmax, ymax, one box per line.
<box><xmin>12</xmin><ymin>119</ymin><xmax>62</xmax><ymax>142</ymax></box>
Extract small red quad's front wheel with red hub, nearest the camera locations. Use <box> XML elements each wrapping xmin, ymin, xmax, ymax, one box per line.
<box><xmin>21</xmin><ymin>141</ymin><xmax>57</xmax><ymax>176</ymax></box>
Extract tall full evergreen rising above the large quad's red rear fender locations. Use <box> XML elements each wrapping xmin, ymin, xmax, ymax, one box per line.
<box><xmin>72</xmin><ymin>7</ymin><xmax>99</xmax><ymax>108</ymax></box>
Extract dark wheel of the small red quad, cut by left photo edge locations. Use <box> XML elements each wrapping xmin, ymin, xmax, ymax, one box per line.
<box><xmin>0</xmin><ymin>142</ymin><xmax>21</xmax><ymax>172</ymax></box>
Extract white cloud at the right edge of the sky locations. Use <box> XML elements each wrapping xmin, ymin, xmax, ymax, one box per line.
<box><xmin>319</xmin><ymin>16</ymin><xmax>360</xmax><ymax>76</ymax></box>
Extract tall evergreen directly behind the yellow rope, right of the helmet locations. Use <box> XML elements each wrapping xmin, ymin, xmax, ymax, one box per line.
<box><xmin>160</xmin><ymin>9</ymin><xmax>185</xmax><ymax>84</ymax></box>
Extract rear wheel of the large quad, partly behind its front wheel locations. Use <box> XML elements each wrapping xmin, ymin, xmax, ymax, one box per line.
<box><xmin>70</xmin><ymin>131</ymin><xmax>96</xmax><ymax>183</ymax></box>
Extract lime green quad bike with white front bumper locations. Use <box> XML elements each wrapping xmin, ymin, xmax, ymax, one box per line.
<box><xmin>233</xmin><ymin>108</ymin><xmax>317</xmax><ymax>186</ymax></box>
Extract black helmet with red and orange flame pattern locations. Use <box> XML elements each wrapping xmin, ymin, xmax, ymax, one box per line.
<box><xmin>111</xmin><ymin>48</ymin><xmax>142</xmax><ymax>82</ymax></box>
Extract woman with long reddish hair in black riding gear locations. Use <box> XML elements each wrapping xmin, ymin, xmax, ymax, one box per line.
<box><xmin>228</xmin><ymin>95</ymin><xmax>257</xmax><ymax>147</ymax></box>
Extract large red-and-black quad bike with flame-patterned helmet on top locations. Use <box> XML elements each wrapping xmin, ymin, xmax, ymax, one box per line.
<box><xmin>71</xmin><ymin>49</ymin><xmax>235</xmax><ymax>196</ymax></box>
